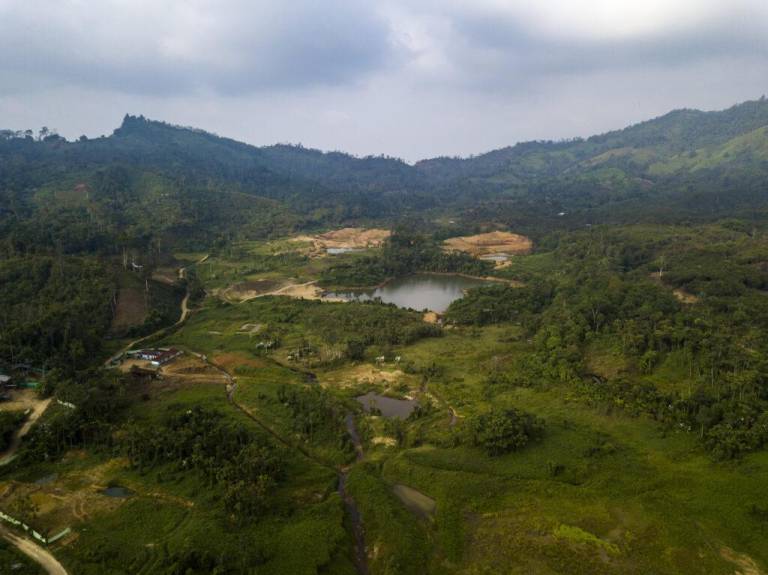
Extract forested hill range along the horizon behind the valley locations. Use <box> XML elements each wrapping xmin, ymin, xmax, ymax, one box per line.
<box><xmin>0</xmin><ymin>98</ymin><xmax>768</xmax><ymax>251</ymax></box>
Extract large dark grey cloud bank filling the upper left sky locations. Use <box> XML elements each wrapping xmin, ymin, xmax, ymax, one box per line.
<box><xmin>0</xmin><ymin>0</ymin><xmax>395</xmax><ymax>94</ymax></box>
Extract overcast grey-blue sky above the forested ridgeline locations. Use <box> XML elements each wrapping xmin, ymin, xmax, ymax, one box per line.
<box><xmin>0</xmin><ymin>0</ymin><xmax>768</xmax><ymax>161</ymax></box>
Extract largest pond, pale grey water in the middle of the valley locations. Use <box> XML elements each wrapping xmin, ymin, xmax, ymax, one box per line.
<box><xmin>327</xmin><ymin>274</ymin><xmax>490</xmax><ymax>313</ymax></box>
